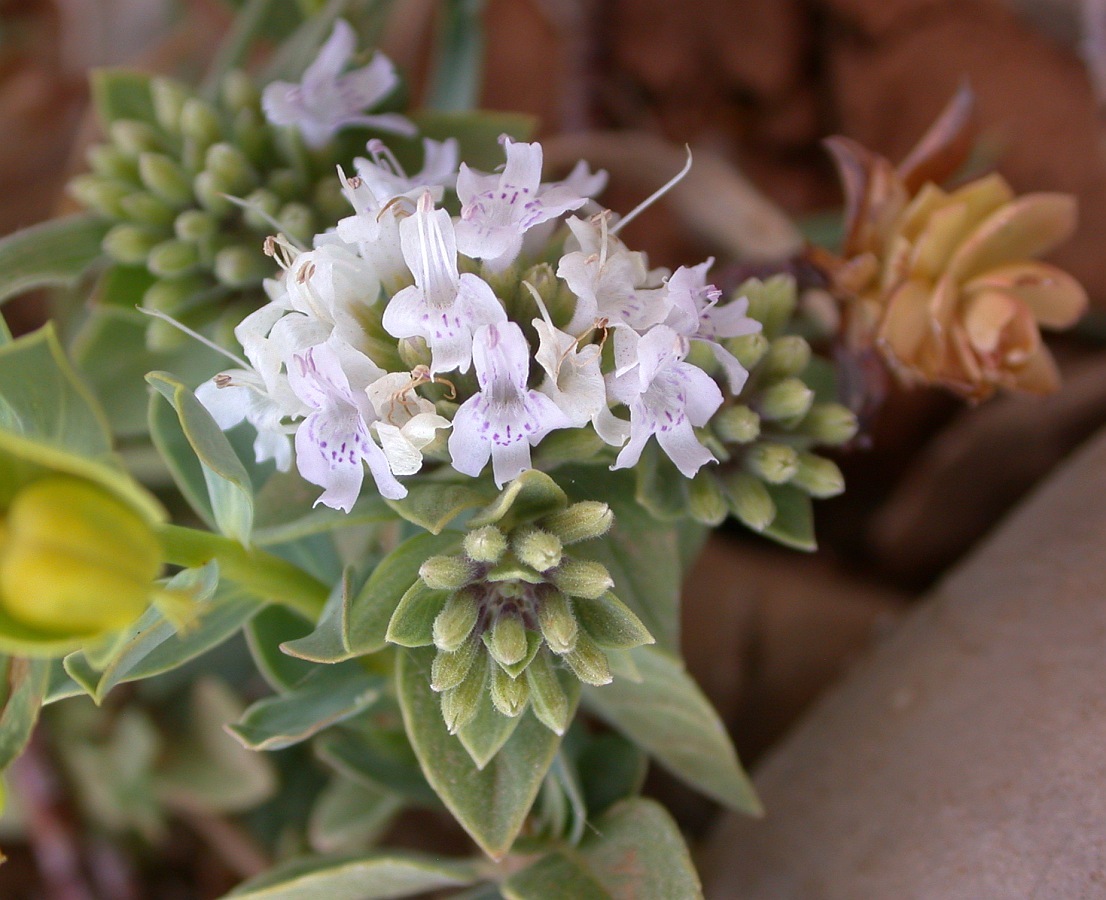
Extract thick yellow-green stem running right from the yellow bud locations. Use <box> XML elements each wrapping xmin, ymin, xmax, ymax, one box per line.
<box><xmin>158</xmin><ymin>525</ymin><xmax>330</xmax><ymax>621</ymax></box>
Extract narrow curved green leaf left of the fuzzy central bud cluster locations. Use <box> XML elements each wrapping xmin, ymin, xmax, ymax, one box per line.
<box><xmin>346</xmin><ymin>532</ymin><xmax>461</xmax><ymax>655</ymax></box>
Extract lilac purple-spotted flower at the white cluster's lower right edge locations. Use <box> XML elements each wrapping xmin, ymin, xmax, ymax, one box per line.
<box><xmin>608</xmin><ymin>325</ymin><xmax>722</xmax><ymax>478</ymax></box>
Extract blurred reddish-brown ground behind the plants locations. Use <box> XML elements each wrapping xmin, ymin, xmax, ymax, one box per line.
<box><xmin>0</xmin><ymin>0</ymin><xmax>1106</xmax><ymax>898</ymax></box>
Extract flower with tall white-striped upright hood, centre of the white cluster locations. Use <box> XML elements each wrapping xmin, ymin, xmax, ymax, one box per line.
<box><xmin>383</xmin><ymin>191</ymin><xmax>507</xmax><ymax>375</ymax></box>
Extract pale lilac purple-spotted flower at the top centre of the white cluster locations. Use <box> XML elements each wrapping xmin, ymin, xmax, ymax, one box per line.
<box><xmin>457</xmin><ymin>135</ymin><xmax>587</xmax><ymax>270</ymax></box>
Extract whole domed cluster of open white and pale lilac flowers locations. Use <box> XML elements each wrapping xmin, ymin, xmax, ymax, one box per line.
<box><xmin>199</xmin><ymin>24</ymin><xmax>761</xmax><ymax>510</ymax></box>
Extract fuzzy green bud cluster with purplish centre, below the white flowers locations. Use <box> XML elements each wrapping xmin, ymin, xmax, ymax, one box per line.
<box><xmin>389</xmin><ymin>501</ymin><xmax>653</xmax><ymax>734</ymax></box>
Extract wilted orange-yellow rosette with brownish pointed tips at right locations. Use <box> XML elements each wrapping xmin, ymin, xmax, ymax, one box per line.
<box><xmin>821</xmin><ymin>91</ymin><xmax>1087</xmax><ymax>399</ymax></box>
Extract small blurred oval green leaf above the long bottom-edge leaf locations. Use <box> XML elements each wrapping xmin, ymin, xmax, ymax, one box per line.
<box><xmin>307</xmin><ymin>773</ymin><xmax>404</xmax><ymax>854</ymax></box>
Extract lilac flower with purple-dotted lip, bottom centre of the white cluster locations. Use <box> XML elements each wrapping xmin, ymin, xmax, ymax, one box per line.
<box><xmin>449</xmin><ymin>322</ymin><xmax>568</xmax><ymax>488</ymax></box>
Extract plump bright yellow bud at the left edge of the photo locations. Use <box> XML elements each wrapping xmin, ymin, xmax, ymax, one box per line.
<box><xmin>0</xmin><ymin>475</ymin><xmax>161</xmax><ymax>635</ymax></box>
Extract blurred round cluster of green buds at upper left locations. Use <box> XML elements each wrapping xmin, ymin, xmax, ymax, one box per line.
<box><xmin>70</xmin><ymin>72</ymin><xmax>345</xmax><ymax>346</ymax></box>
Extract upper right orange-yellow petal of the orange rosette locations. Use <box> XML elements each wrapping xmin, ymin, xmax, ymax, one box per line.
<box><xmin>948</xmin><ymin>193</ymin><xmax>1075</xmax><ymax>282</ymax></box>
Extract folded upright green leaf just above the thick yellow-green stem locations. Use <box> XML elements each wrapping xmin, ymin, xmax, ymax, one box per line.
<box><xmin>146</xmin><ymin>371</ymin><xmax>253</xmax><ymax>544</ymax></box>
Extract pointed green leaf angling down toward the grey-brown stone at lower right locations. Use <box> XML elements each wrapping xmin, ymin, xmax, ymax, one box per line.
<box><xmin>584</xmin><ymin>647</ymin><xmax>761</xmax><ymax>815</ymax></box>
